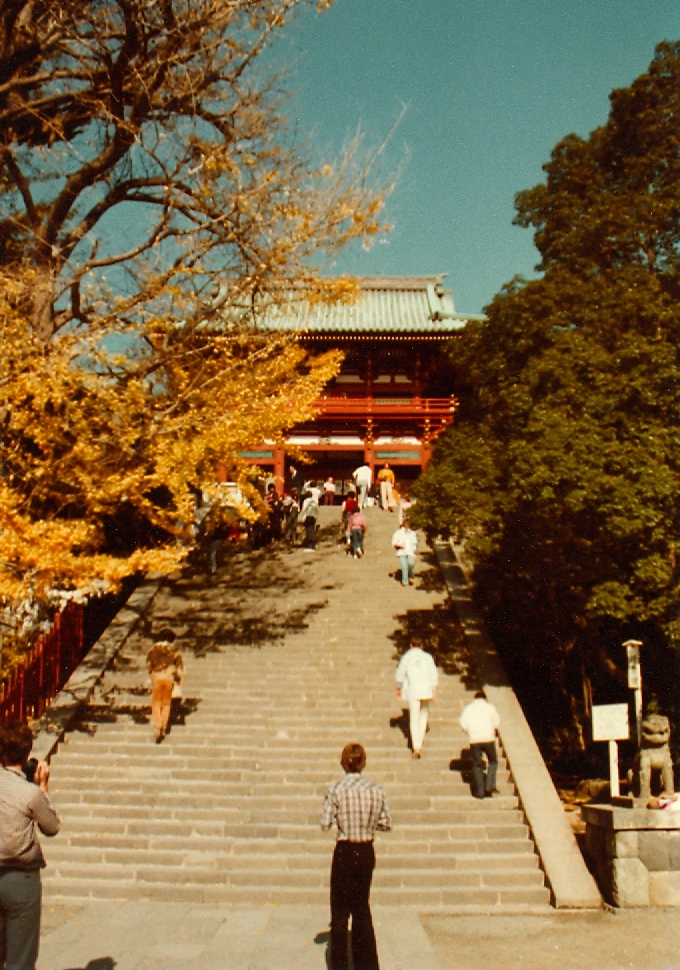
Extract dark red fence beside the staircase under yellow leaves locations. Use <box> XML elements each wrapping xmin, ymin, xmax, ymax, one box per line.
<box><xmin>0</xmin><ymin>603</ymin><xmax>83</xmax><ymax>722</ymax></box>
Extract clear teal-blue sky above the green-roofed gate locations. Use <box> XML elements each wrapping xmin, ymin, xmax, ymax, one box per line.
<box><xmin>278</xmin><ymin>0</ymin><xmax>680</xmax><ymax>313</ymax></box>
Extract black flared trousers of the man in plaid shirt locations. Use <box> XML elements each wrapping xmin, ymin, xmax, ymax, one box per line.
<box><xmin>330</xmin><ymin>842</ymin><xmax>379</xmax><ymax>970</ymax></box>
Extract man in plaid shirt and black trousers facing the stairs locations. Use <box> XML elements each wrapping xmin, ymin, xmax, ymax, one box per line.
<box><xmin>321</xmin><ymin>744</ymin><xmax>392</xmax><ymax>970</ymax></box>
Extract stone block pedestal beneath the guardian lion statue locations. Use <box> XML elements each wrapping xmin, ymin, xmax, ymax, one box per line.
<box><xmin>582</xmin><ymin>805</ymin><xmax>680</xmax><ymax>907</ymax></box>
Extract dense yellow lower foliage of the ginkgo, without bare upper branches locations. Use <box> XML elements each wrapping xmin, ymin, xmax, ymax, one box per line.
<box><xmin>0</xmin><ymin>264</ymin><xmax>346</xmax><ymax>628</ymax></box>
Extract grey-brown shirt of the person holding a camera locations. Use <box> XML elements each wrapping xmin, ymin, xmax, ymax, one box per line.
<box><xmin>0</xmin><ymin>768</ymin><xmax>59</xmax><ymax>872</ymax></box>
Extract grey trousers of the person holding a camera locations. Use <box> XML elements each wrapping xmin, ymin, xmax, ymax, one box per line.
<box><xmin>0</xmin><ymin>869</ymin><xmax>41</xmax><ymax>970</ymax></box>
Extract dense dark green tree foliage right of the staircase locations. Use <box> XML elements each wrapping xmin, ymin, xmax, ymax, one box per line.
<box><xmin>417</xmin><ymin>43</ymin><xmax>680</xmax><ymax>754</ymax></box>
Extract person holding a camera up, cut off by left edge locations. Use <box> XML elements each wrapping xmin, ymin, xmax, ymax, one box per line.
<box><xmin>0</xmin><ymin>722</ymin><xmax>59</xmax><ymax>970</ymax></box>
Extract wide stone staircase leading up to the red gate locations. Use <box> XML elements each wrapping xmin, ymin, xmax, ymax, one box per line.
<box><xmin>43</xmin><ymin>509</ymin><xmax>549</xmax><ymax>912</ymax></box>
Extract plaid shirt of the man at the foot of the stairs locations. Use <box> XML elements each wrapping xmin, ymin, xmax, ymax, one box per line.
<box><xmin>321</xmin><ymin>773</ymin><xmax>392</xmax><ymax>842</ymax></box>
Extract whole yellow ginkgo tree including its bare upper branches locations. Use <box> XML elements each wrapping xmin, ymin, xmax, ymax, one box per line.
<box><xmin>0</xmin><ymin>0</ymin><xmax>389</xmax><ymax>640</ymax></box>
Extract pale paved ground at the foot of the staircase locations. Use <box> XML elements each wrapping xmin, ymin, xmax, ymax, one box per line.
<box><xmin>39</xmin><ymin>902</ymin><xmax>680</xmax><ymax>970</ymax></box>
